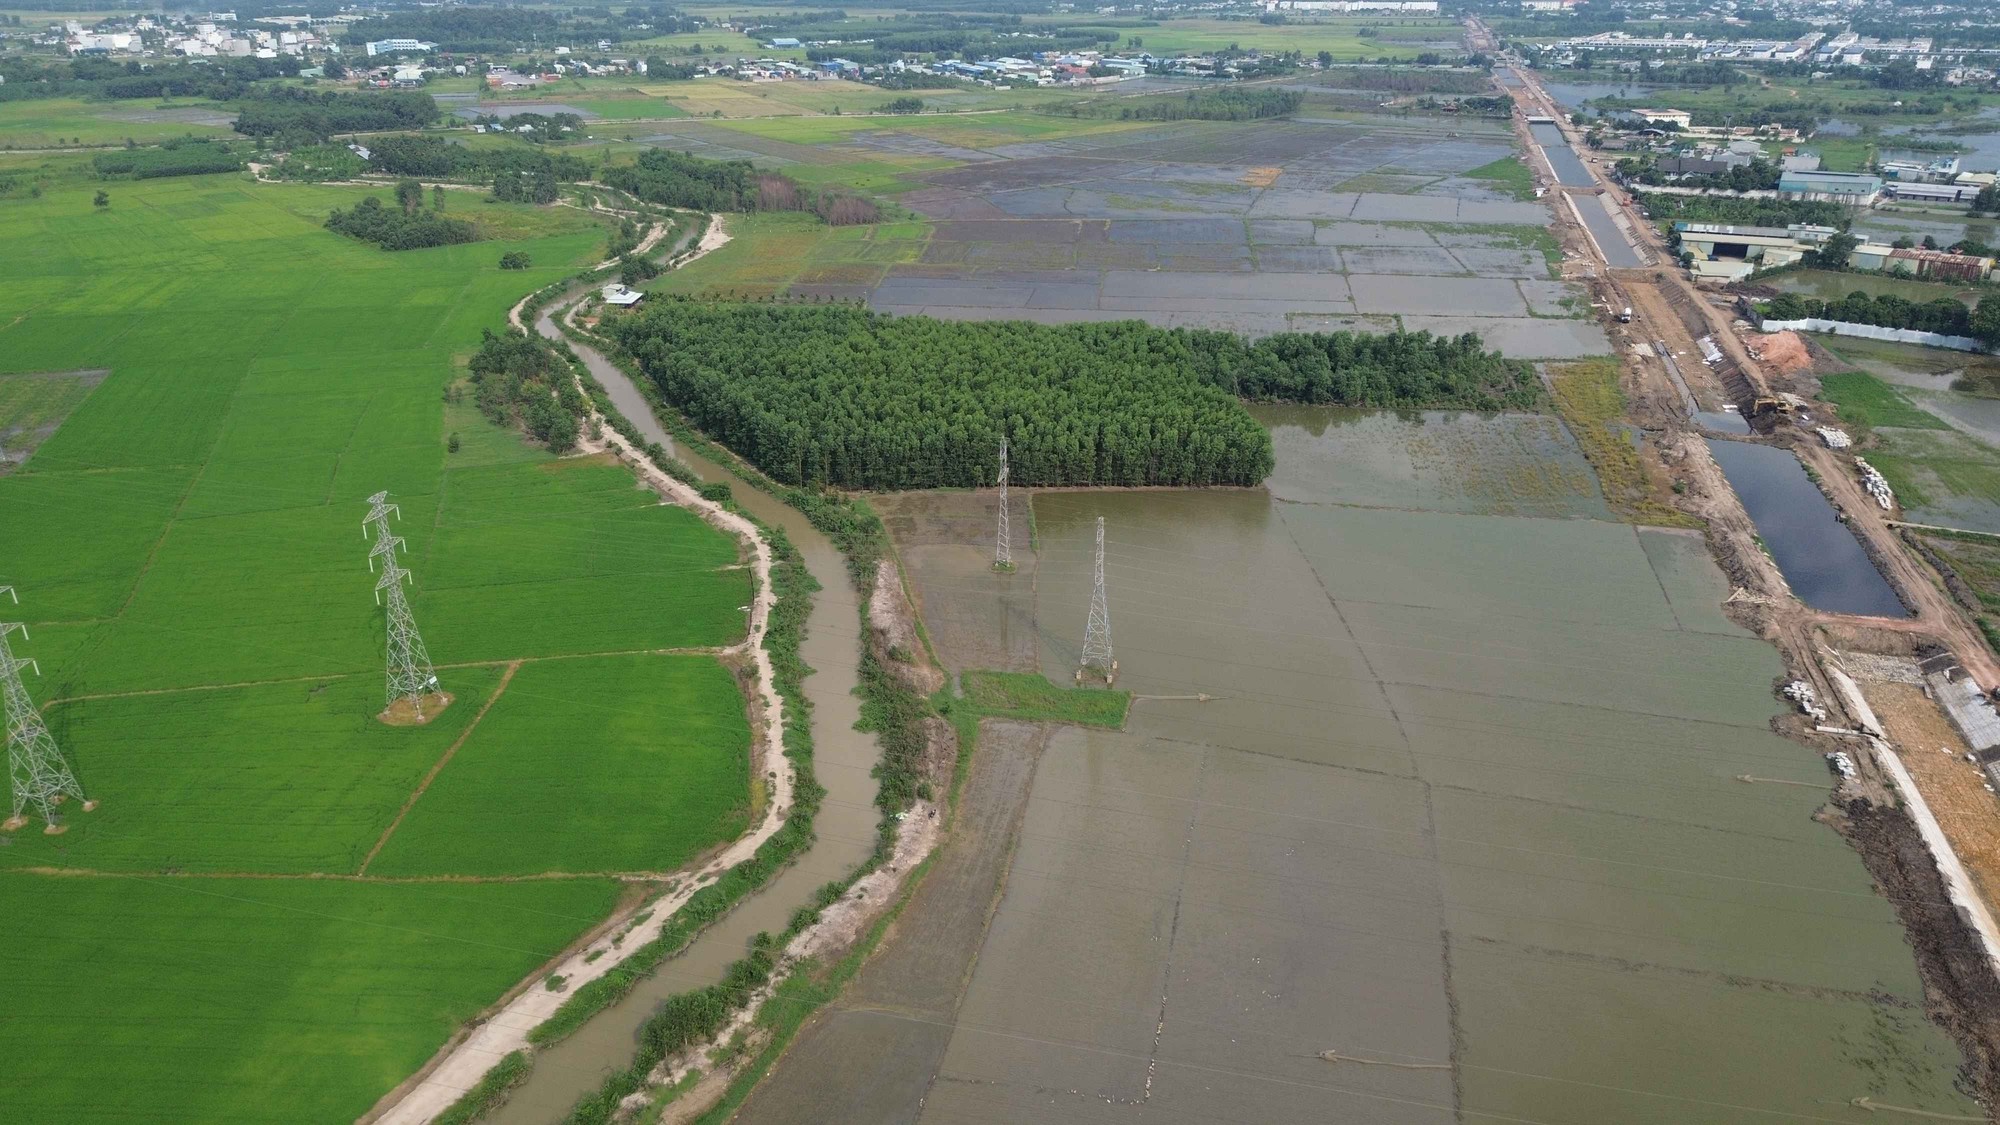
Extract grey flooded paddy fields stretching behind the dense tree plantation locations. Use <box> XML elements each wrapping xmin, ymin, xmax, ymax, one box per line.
<box><xmin>844</xmin><ymin>118</ymin><xmax>1610</xmax><ymax>358</ymax></box>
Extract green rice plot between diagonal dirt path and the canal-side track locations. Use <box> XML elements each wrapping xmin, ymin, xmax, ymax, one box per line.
<box><xmin>370</xmin><ymin>655</ymin><xmax>750</xmax><ymax>875</ymax></box>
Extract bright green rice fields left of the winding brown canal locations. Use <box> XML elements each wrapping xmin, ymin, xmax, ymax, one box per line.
<box><xmin>0</xmin><ymin>176</ymin><xmax>750</xmax><ymax>1121</ymax></box>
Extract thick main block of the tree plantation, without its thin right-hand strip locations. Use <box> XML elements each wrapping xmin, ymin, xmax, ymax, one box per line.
<box><xmin>610</xmin><ymin>300</ymin><xmax>1272</xmax><ymax>488</ymax></box>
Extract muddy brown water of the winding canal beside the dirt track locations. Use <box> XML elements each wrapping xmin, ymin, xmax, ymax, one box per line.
<box><xmin>486</xmin><ymin>308</ymin><xmax>880</xmax><ymax>1125</ymax></box>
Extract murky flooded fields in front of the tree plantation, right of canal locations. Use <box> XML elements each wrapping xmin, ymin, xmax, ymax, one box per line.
<box><xmin>738</xmin><ymin>410</ymin><xmax>1978</xmax><ymax>1125</ymax></box>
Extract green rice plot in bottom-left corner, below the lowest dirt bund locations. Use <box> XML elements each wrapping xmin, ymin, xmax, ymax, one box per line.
<box><xmin>0</xmin><ymin>873</ymin><xmax>618</xmax><ymax>1125</ymax></box>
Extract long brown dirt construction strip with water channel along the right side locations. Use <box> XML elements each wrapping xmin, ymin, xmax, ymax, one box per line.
<box><xmin>1506</xmin><ymin>41</ymin><xmax>2000</xmax><ymax>1105</ymax></box>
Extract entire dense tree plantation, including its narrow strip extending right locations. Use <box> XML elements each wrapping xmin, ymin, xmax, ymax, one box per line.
<box><xmin>608</xmin><ymin>298</ymin><xmax>1536</xmax><ymax>488</ymax></box>
